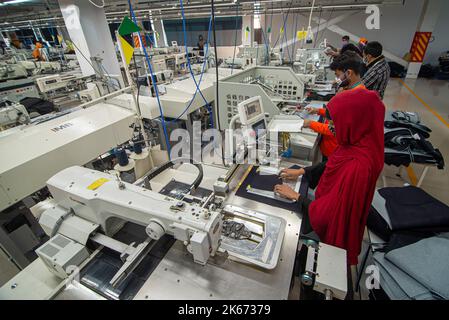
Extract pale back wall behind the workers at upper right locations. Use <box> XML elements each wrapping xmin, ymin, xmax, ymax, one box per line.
<box><xmin>254</xmin><ymin>0</ymin><xmax>449</xmax><ymax>64</ymax></box>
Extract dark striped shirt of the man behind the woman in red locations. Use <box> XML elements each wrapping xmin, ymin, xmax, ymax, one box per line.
<box><xmin>362</xmin><ymin>56</ymin><xmax>390</xmax><ymax>99</ymax></box>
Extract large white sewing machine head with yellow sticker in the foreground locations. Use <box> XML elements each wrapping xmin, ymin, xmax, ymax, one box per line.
<box><xmin>37</xmin><ymin>167</ymin><xmax>222</xmax><ymax>282</ymax></box>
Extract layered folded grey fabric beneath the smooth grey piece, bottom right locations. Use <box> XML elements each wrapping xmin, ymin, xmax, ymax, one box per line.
<box><xmin>374</xmin><ymin>252</ymin><xmax>434</xmax><ymax>300</ymax></box>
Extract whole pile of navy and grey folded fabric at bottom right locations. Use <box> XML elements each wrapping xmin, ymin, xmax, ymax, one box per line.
<box><xmin>367</xmin><ymin>187</ymin><xmax>449</xmax><ymax>300</ymax></box>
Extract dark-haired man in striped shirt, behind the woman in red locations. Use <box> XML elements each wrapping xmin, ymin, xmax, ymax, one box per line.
<box><xmin>362</xmin><ymin>41</ymin><xmax>390</xmax><ymax>99</ymax></box>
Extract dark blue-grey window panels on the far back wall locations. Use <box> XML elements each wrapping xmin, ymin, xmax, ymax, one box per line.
<box><xmin>164</xmin><ymin>17</ymin><xmax>242</xmax><ymax>47</ymax></box>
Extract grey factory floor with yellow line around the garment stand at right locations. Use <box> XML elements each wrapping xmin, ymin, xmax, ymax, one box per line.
<box><xmin>379</xmin><ymin>79</ymin><xmax>449</xmax><ymax>205</ymax></box>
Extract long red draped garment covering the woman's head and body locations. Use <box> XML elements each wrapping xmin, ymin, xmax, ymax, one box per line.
<box><xmin>309</xmin><ymin>90</ymin><xmax>385</xmax><ymax>265</ymax></box>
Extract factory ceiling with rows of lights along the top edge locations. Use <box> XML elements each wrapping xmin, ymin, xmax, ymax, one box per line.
<box><xmin>0</xmin><ymin>0</ymin><xmax>404</xmax><ymax>31</ymax></box>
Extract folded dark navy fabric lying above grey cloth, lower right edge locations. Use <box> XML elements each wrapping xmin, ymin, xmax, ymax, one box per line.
<box><xmin>379</xmin><ymin>186</ymin><xmax>449</xmax><ymax>230</ymax></box>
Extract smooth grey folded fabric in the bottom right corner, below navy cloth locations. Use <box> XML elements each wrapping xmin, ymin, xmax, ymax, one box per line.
<box><xmin>385</xmin><ymin>234</ymin><xmax>449</xmax><ymax>299</ymax></box>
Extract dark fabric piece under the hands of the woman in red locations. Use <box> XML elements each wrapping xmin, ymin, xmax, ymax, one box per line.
<box><xmin>236</xmin><ymin>166</ymin><xmax>303</xmax><ymax>212</ymax></box>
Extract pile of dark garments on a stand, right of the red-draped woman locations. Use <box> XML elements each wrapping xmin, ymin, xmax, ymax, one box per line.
<box><xmin>385</xmin><ymin>111</ymin><xmax>444</xmax><ymax>170</ymax></box>
